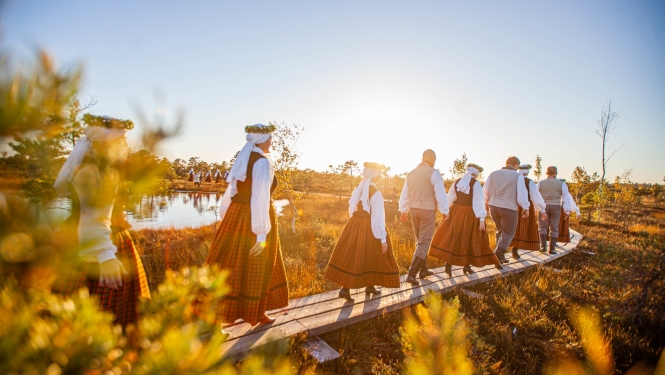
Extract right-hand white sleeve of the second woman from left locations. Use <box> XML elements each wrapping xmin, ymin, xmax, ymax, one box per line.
<box><xmin>249</xmin><ymin>158</ymin><xmax>274</xmax><ymax>242</ymax></box>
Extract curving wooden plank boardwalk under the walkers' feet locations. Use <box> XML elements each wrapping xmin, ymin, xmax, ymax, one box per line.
<box><xmin>222</xmin><ymin>230</ymin><xmax>582</xmax><ymax>356</ymax></box>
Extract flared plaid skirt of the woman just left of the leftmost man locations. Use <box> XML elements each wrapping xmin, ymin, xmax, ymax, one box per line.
<box><xmin>324</xmin><ymin>216</ymin><xmax>399</xmax><ymax>288</ymax></box>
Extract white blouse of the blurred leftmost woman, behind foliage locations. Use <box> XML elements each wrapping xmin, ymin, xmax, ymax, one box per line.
<box><xmin>72</xmin><ymin>166</ymin><xmax>118</xmax><ymax>263</ymax></box>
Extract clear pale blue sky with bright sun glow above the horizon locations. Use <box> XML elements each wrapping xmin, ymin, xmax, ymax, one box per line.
<box><xmin>0</xmin><ymin>0</ymin><xmax>665</xmax><ymax>182</ymax></box>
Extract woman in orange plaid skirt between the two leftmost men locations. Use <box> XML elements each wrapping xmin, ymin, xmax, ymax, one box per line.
<box><xmin>429</xmin><ymin>164</ymin><xmax>502</xmax><ymax>277</ymax></box>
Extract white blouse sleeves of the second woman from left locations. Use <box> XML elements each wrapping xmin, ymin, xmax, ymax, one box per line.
<box><xmin>219</xmin><ymin>147</ymin><xmax>275</xmax><ymax>242</ymax></box>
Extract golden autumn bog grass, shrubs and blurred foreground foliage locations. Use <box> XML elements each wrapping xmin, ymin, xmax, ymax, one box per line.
<box><xmin>0</xmin><ymin>41</ymin><xmax>665</xmax><ymax>374</ymax></box>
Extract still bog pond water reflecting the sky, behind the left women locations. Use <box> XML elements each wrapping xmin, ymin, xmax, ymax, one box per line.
<box><xmin>44</xmin><ymin>192</ymin><xmax>288</xmax><ymax>229</ymax></box>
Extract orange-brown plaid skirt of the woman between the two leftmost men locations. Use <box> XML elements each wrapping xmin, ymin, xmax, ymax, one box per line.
<box><xmin>429</xmin><ymin>204</ymin><xmax>499</xmax><ymax>267</ymax></box>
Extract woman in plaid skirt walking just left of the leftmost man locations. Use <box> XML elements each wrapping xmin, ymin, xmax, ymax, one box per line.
<box><xmin>324</xmin><ymin>162</ymin><xmax>399</xmax><ymax>302</ymax></box>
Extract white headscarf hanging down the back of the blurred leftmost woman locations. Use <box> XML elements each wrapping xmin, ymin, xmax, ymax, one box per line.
<box><xmin>53</xmin><ymin>126</ymin><xmax>127</xmax><ymax>196</ymax></box>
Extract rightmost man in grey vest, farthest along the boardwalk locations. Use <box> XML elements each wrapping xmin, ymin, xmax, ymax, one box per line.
<box><xmin>536</xmin><ymin>166</ymin><xmax>572</xmax><ymax>254</ymax></box>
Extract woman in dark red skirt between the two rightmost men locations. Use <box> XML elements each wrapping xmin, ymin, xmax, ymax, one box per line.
<box><xmin>510</xmin><ymin>164</ymin><xmax>547</xmax><ymax>259</ymax></box>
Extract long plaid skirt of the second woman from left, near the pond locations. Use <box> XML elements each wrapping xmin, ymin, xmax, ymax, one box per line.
<box><xmin>206</xmin><ymin>203</ymin><xmax>289</xmax><ymax>325</ymax></box>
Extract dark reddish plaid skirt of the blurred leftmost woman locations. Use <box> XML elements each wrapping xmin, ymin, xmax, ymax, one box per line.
<box><xmin>52</xmin><ymin>230</ymin><xmax>150</xmax><ymax>327</ymax></box>
